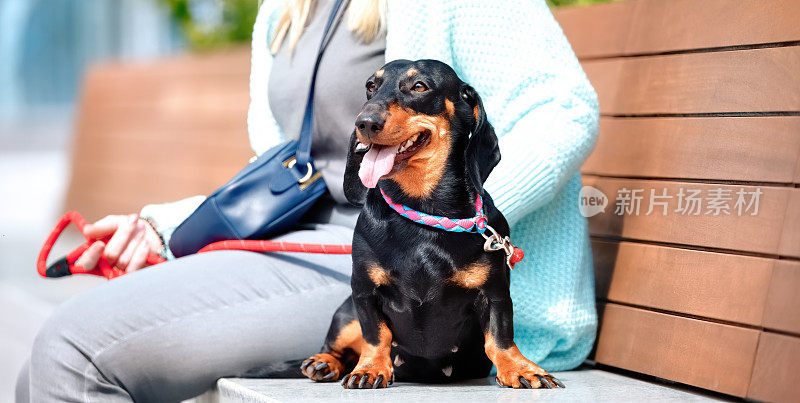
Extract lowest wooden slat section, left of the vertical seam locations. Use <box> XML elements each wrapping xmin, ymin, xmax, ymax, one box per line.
<box><xmin>595</xmin><ymin>303</ymin><xmax>759</xmax><ymax>397</ymax></box>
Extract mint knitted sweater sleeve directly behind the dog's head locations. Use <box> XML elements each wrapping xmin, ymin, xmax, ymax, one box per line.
<box><xmin>386</xmin><ymin>0</ymin><xmax>599</xmax><ymax>224</ymax></box>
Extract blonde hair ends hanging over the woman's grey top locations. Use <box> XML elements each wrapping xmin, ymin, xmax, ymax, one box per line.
<box><xmin>269</xmin><ymin>0</ymin><xmax>387</xmax><ymax>55</ymax></box>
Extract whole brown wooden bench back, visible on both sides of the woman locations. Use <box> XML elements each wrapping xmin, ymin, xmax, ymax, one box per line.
<box><xmin>67</xmin><ymin>0</ymin><xmax>800</xmax><ymax>401</ymax></box>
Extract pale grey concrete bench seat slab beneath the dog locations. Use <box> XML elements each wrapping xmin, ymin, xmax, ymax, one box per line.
<box><xmin>198</xmin><ymin>369</ymin><xmax>715</xmax><ymax>403</ymax></box>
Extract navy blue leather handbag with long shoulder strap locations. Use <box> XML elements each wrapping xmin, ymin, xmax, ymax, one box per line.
<box><xmin>169</xmin><ymin>0</ymin><xmax>342</xmax><ymax>257</ymax></box>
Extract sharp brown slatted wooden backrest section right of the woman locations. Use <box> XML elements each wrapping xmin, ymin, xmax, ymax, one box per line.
<box><xmin>555</xmin><ymin>0</ymin><xmax>800</xmax><ymax>401</ymax></box>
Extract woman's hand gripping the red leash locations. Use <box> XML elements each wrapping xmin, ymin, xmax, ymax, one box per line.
<box><xmin>75</xmin><ymin>214</ymin><xmax>161</xmax><ymax>273</ymax></box>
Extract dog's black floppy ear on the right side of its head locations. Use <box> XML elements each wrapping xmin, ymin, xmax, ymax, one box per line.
<box><xmin>461</xmin><ymin>84</ymin><xmax>500</xmax><ymax>193</ymax></box>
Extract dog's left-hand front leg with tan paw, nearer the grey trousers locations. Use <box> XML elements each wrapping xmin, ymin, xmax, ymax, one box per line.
<box><xmin>342</xmin><ymin>290</ymin><xmax>394</xmax><ymax>389</ymax></box>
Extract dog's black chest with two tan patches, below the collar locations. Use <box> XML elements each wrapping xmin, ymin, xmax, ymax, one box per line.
<box><xmin>359</xmin><ymin>221</ymin><xmax>491</xmax><ymax>357</ymax></box>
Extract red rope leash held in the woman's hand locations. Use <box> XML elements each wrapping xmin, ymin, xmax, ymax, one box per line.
<box><xmin>36</xmin><ymin>211</ymin><xmax>352</xmax><ymax>280</ymax></box>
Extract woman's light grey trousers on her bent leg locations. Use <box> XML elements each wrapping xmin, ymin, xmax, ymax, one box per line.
<box><xmin>16</xmin><ymin>218</ymin><xmax>352</xmax><ymax>402</ymax></box>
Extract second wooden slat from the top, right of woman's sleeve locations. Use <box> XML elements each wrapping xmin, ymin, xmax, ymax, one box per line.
<box><xmin>583</xmin><ymin>46</ymin><xmax>800</xmax><ymax>115</ymax></box>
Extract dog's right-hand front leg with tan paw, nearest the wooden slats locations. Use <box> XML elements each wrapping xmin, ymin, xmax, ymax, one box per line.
<box><xmin>483</xmin><ymin>283</ymin><xmax>564</xmax><ymax>389</ymax></box>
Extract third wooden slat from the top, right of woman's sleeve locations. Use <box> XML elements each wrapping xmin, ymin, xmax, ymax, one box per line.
<box><xmin>581</xmin><ymin>116</ymin><xmax>800</xmax><ymax>183</ymax></box>
